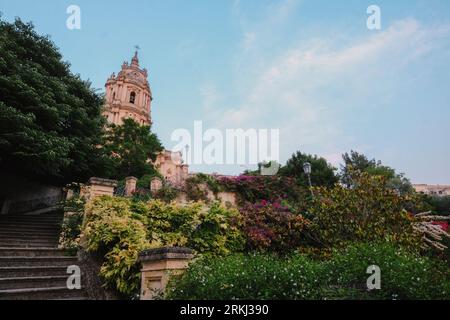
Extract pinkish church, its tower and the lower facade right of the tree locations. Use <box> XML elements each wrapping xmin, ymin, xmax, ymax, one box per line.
<box><xmin>103</xmin><ymin>52</ymin><xmax>189</xmax><ymax>186</ymax></box>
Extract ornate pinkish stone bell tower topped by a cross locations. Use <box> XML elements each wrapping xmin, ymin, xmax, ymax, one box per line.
<box><xmin>104</xmin><ymin>51</ymin><xmax>153</xmax><ymax>125</ymax></box>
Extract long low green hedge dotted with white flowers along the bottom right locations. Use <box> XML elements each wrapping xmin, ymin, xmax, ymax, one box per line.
<box><xmin>167</xmin><ymin>243</ymin><xmax>450</xmax><ymax>300</ymax></box>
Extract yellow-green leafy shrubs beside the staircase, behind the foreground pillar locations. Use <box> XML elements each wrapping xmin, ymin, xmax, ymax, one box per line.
<box><xmin>83</xmin><ymin>196</ymin><xmax>243</xmax><ymax>297</ymax></box>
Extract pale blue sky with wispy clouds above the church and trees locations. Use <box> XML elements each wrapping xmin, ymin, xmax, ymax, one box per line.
<box><xmin>0</xmin><ymin>0</ymin><xmax>450</xmax><ymax>184</ymax></box>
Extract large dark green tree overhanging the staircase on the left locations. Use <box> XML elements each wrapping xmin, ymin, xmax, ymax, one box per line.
<box><xmin>0</xmin><ymin>19</ymin><xmax>106</xmax><ymax>183</ymax></box>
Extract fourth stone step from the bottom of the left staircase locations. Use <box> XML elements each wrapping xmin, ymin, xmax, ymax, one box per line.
<box><xmin>0</xmin><ymin>256</ymin><xmax>78</xmax><ymax>267</ymax></box>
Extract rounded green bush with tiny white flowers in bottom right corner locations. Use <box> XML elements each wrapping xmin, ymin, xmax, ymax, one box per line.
<box><xmin>325</xmin><ymin>243</ymin><xmax>450</xmax><ymax>300</ymax></box>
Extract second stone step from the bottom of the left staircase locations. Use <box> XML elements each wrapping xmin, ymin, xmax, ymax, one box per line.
<box><xmin>0</xmin><ymin>275</ymin><xmax>69</xmax><ymax>290</ymax></box>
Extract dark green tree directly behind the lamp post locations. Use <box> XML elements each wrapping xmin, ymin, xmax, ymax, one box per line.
<box><xmin>279</xmin><ymin>151</ymin><xmax>339</xmax><ymax>187</ymax></box>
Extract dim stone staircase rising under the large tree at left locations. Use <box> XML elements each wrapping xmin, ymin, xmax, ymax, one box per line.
<box><xmin>0</xmin><ymin>209</ymin><xmax>87</xmax><ymax>300</ymax></box>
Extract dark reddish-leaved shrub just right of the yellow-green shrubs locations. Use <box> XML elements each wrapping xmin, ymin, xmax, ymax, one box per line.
<box><xmin>240</xmin><ymin>201</ymin><xmax>308</xmax><ymax>253</ymax></box>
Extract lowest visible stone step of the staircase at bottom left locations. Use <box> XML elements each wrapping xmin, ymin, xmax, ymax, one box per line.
<box><xmin>0</xmin><ymin>286</ymin><xmax>86</xmax><ymax>300</ymax></box>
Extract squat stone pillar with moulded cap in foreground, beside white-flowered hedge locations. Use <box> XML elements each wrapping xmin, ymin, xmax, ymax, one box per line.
<box><xmin>139</xmin><ymin>247</ymin><xmax>194</xmax><ymax>300</ymax></box>
